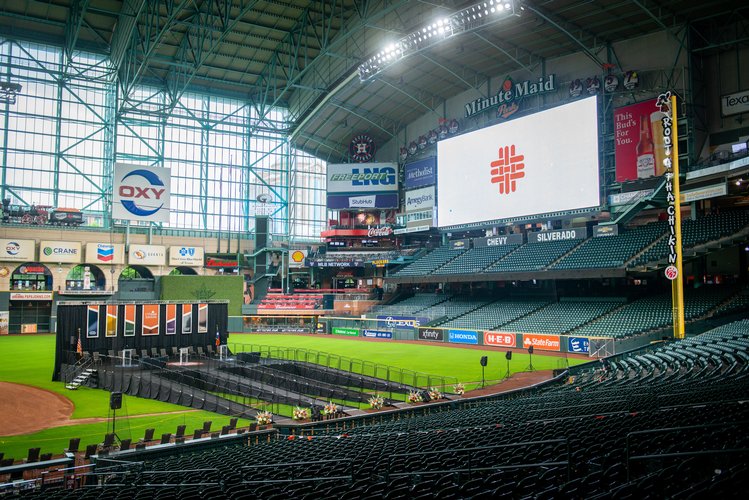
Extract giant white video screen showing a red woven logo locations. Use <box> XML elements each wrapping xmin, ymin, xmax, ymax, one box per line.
<box><xmin>437</xmin><ymin>96</ymin><xmax>600</xmax><ymax>228</ymax></box>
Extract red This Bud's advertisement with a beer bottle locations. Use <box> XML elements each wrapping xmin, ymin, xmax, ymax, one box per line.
<box><xmin>614</xmin><ymin>99</ymin><xmax>664</xmax><ymax>182</ymax></box>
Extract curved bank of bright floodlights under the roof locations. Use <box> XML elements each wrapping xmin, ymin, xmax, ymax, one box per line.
<box><xmin>359</xmin><ymin>0</ymin><xmax>522</xmax><ymax>82</ymax></box>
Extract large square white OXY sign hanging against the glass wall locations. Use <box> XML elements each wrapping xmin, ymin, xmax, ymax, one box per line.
<box><xmin>112</xmin><ymin>163</ymin><xmax>172</xmax><ymax>222</ymax></box>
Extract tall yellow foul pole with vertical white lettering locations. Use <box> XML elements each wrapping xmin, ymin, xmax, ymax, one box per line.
<box><xmin>653</xmin><ymin>91</ymin><xmax>684</xmax><ymax>339</ymax></box>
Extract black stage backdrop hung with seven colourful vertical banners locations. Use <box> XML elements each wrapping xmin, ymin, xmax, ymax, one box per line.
<box><xmin>52</xmin><ymin>301</ymin><xmax>229</xmax><ymax>381</ymax></box>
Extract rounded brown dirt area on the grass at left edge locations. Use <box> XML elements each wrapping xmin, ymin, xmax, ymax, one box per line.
<box><xmin>0</xmin><ymin>382</ymin><xmax>74</xmax><ymax>436</ymax></box>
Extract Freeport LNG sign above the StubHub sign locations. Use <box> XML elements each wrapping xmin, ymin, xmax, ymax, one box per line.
<box><xmin>327</xmin><ymin>163</ymin><xmax>398</xmax><ymax>194</ymax></box>
